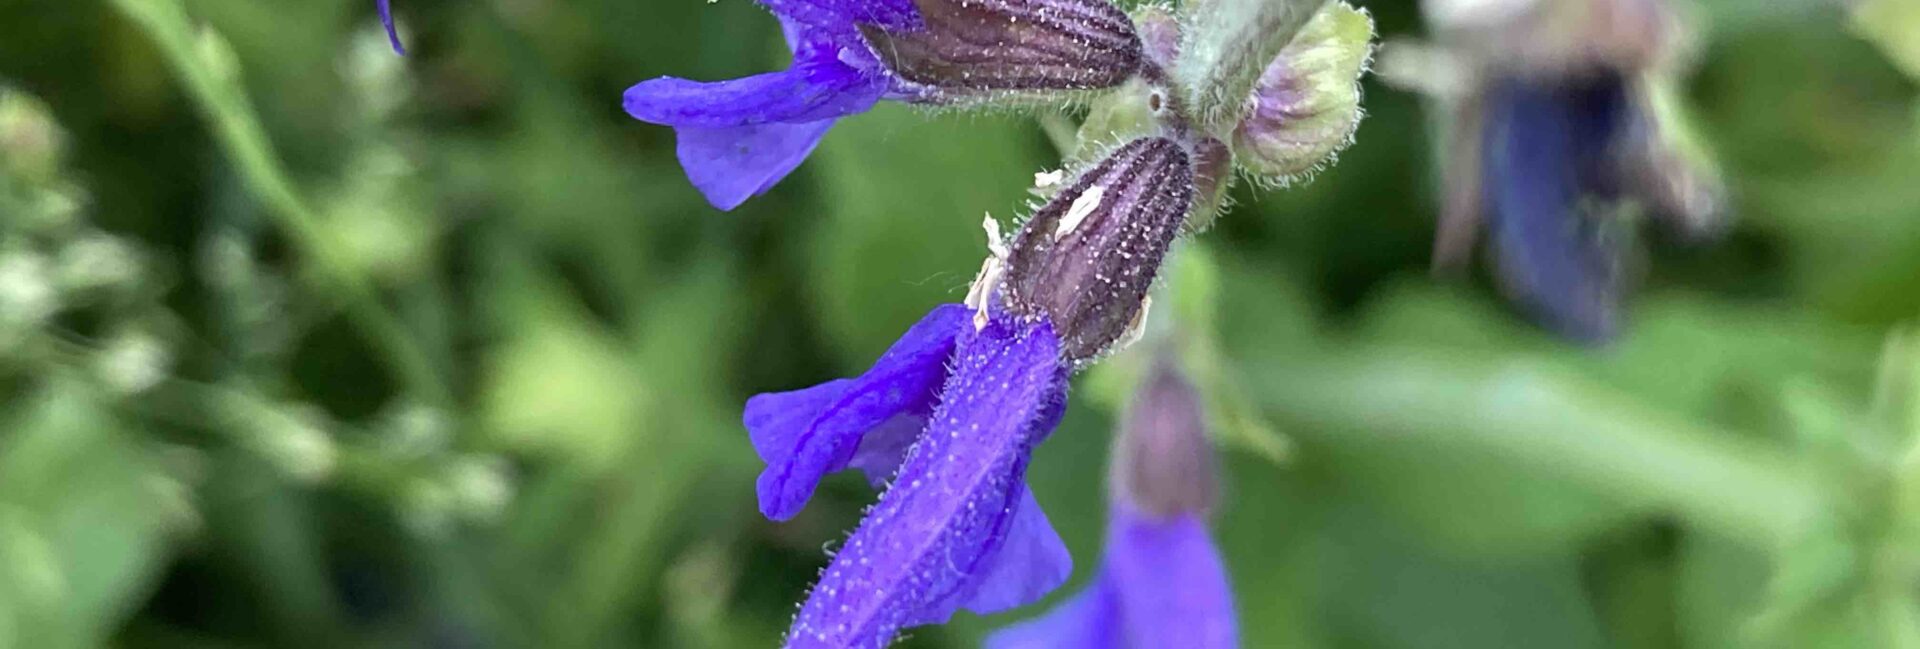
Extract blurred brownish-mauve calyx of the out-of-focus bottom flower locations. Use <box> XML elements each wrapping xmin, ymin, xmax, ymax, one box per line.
<box><xmin>1108</xmin><ymin>349</ymin><xmax>1219</xmax><ymax>518</ymax></box>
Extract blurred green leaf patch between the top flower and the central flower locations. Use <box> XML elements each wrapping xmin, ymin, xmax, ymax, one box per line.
<box><xmin>810</xmin><ymin>106</ymin><xmax>1052</xmax><ymax>367</ymax></box>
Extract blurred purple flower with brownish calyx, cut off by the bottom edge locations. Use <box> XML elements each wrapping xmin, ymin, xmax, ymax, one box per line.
<box><xmin>987</xmin><ymin>349</ymin><xmax>1238</xmax><ymax>649</ymax></box>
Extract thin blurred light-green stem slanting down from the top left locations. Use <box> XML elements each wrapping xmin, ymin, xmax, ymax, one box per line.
<box><xmin>113</xmin><ymin>0</ymin><xmax>451</xmax><ymax>405</ymax></box>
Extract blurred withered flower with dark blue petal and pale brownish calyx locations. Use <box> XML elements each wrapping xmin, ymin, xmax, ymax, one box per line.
<box><xmin>1384</xmin><ymin>0</ymin><xmax>1724</xmax><ymax>342</ymax></box>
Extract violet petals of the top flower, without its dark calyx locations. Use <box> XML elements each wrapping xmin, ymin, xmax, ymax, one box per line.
<box><xmin>624</xmin><ymin>0</ymin><xmax>920</xmax><ymax>209</ymax></box>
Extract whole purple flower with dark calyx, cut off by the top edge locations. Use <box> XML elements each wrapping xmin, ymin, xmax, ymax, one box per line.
<box><xmin>624</xmin><ymin>0</ymin><xmax>1142</xmax><ymax>209</ymax></box>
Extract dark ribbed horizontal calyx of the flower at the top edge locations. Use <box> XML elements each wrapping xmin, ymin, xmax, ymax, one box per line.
<box><xmin>860</xmin><ymin>0</ymin><xmax>1144</xmax><ymax>102</ymax></box>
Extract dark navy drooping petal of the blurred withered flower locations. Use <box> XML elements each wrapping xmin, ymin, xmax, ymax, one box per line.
<box><xmin>1480</xmin><ymin>73</ymin><xmax>1634</xmax><ymax>340</ymax></box>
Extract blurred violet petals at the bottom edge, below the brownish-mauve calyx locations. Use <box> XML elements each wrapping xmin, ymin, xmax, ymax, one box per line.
<box><xmin>987</xmin><ymin>505</ymin><xmax>1238</xmax><ymax>649</ymax></box>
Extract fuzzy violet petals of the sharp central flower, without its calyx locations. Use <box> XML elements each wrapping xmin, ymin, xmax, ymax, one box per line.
<box><xmin>745</xmin><ymin>305</ymin><xmax>1073</xmax><ymax>647</ymax></box>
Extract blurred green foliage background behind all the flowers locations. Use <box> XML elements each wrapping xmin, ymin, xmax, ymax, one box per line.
<box><xmin>0</xmin><ymin>0</ymin><xmax>1920</xmax><ymax>649</ymax></box>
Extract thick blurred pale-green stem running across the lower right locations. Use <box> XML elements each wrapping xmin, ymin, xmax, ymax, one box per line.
<box><xmin>1242</xmin><ymin>349</ymin><xmax>1836</xmax><ymax>551</ymax></box>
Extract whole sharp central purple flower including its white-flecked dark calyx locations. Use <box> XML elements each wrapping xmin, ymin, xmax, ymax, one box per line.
<box><xmin>745</xmin><ymin>138</ymin><xmax>1194</xmax><ymax>647</ymax></box>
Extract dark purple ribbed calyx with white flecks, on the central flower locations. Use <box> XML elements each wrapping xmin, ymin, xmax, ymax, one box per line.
<box><xmin>1004</xmin><ymin>138</ymin><xmax>1194</xmax><ymax>361</ymax></box>
